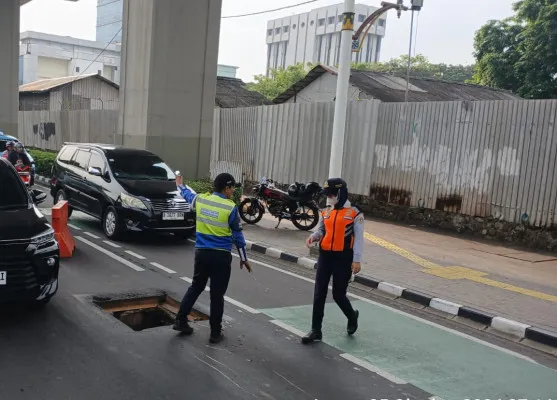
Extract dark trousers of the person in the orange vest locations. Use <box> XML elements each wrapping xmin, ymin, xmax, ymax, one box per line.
<box><xmin>311</xmin><ymin>250</ymin><xmax>354</xmax><ymax>331</ymax></box>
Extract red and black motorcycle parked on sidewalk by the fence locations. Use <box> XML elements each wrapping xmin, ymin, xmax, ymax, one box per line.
<box><xmin>238</xmin><ymin>177</ymin><xmax>323</xmax><ymax>231</ymax></box>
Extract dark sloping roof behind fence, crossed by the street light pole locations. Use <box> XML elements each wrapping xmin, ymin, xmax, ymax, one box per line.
<box><xmin>273</xmin><ymin>65</ymin><xmax>521</xmax><ymax>104</ymax></box>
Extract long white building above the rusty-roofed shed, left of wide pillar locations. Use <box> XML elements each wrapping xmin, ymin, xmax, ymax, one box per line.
<box><xmin>19</xmin><ymin>32</ymin><xmax>121</xmax><ymax>85</ymax></box>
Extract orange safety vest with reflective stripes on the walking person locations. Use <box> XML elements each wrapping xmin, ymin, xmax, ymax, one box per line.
<box><xmin>320</xmin><ymin>207</ymin><xmax>360</xmax><ymax>251</ymax></box>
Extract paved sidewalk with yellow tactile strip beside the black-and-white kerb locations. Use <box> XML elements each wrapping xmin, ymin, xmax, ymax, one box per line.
<box><xmin>243</xmin><ymin>215</ymin><xmax>557</xmax><ymax>332</ymax></box>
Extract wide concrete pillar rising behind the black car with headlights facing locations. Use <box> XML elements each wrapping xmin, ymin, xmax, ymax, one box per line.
<box><xmin>117</xmin><ymin>0</ymin><xmax>222</xmax><ymax>179</ymax></box>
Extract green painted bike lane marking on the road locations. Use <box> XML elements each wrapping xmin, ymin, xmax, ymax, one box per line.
<box><xmin>260</xmin><ymin>301</ymin><xmax>557</xmax><ymax>400</ymax></box>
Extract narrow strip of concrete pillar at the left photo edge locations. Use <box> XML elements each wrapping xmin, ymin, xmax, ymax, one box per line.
<box><xmin>0</xmin><ymin>0</ymin><xmax>20</xmax><ymax>136</ymax></box>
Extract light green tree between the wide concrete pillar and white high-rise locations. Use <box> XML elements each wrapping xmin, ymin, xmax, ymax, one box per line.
<box><xmin>246</xmin><ymin>63</ymin><xmax>311</xmax><ymax>100</ymax></box>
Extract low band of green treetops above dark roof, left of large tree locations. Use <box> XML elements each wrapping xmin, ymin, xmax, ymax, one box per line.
<box><xmin>352</xmin><ymin>54</ymin><xmax>475</xmax><ymax>83</ymax></box>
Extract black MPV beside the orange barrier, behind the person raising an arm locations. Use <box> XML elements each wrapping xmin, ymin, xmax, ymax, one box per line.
<box><xmin>50</xmin><ymin>143</ymin><xmax>195</xmax><ymax>240</ymax></box>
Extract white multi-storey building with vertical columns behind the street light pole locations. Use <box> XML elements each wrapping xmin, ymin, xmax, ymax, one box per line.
<box><xmin>267</xmin><ymin>3</ymin><xmax>387</xmax><ymax>72</ymax></box>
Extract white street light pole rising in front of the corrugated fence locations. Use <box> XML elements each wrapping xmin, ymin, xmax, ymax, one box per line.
<box><xmin>329</xmin><ymin>0</ymin><xmax>355</xmax><ymax>178</ymax></box>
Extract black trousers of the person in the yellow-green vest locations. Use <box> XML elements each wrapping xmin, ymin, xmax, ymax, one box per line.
<box><xmin>176</xmin><ymin>249</ymin><xmax>232</xmax><ymax>334</ymax></box>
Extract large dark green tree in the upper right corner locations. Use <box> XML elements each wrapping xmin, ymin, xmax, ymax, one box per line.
<box><xmin>474</xmin><ymin>0</ymin><xmax>557</xmax><ymax>99</ymax></box>
